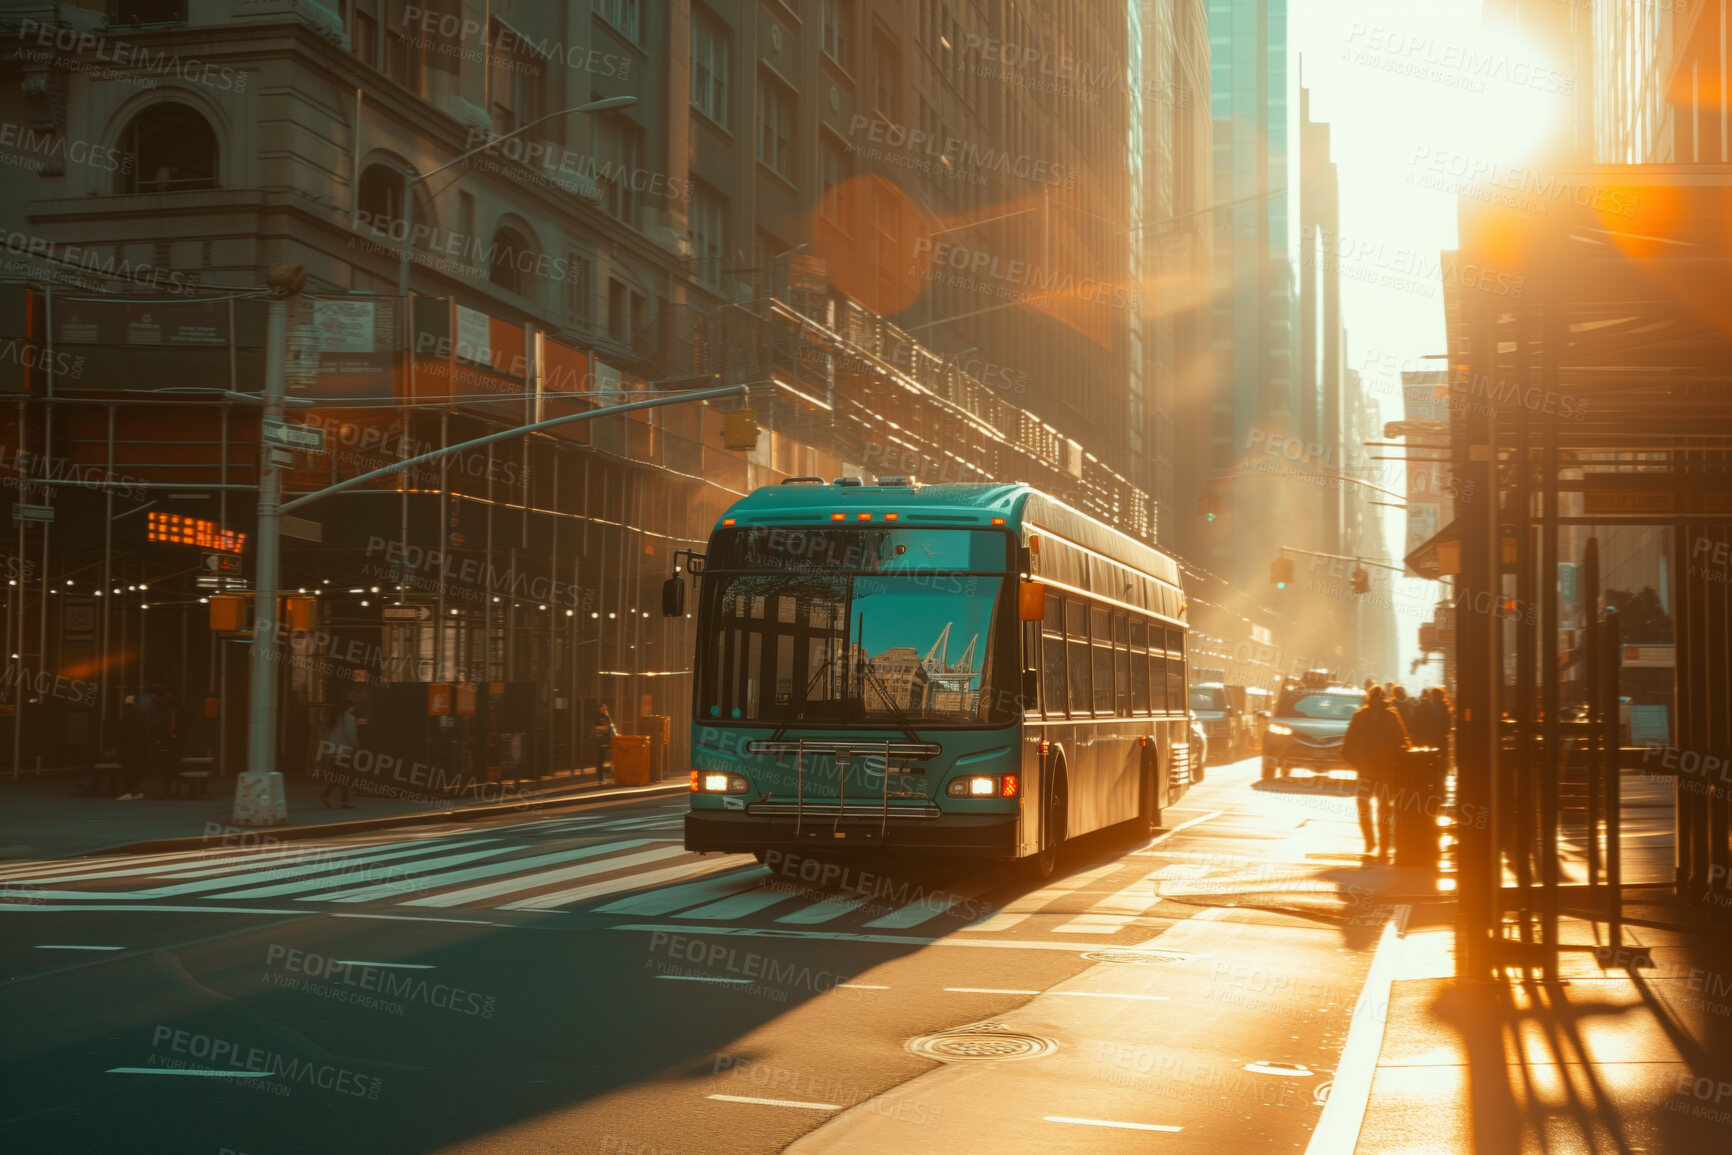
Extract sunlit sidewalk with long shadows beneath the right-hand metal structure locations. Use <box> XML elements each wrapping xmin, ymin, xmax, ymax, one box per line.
<box><xmin>1354</xmin><ymin>902</ymin><xmax>1732</xmax><ymax>1155</ymax></box>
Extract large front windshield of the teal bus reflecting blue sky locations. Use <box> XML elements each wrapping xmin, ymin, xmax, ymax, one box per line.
<box><xmin>696</xmin><ymin>571</ymin><xmax>1017</xmax><ymax>726</ymax></box>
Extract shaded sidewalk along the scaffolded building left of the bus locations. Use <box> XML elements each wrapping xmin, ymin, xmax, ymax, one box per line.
<box><xmin>0</xmin><ymin>769</ymin><xmax>686</xmax><ymax>861</ymax></box>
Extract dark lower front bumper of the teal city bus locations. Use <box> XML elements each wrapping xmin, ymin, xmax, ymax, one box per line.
<box><xmin>686</xmin><ymin>807</ymin><xmax>1017</xmax><ymax>859</ymax></box>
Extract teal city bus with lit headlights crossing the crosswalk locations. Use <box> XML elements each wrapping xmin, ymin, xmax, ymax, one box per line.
<box><xmin>663</xmin><ymin>478</ymin><xmax>1192</xmax><ymax>874</ymax></box>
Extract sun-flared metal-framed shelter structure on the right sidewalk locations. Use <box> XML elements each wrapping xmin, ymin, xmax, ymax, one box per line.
<box><xmin>1439</xmin><ymin>166</ymin><xmax>1732</xmax><ymax>978</ymax></box>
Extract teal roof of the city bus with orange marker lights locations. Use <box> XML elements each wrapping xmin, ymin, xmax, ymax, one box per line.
<box><xmin>717</xmin><ymin>481</ymin><xmax>1179</xmax><ymax>585</ymax></box>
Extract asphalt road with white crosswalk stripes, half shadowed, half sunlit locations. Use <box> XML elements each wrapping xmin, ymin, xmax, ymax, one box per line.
<box><xmin>0</xmin><ymin>760</ymin><xmax>1387</xmax><ymax>1155</ymax></box>
